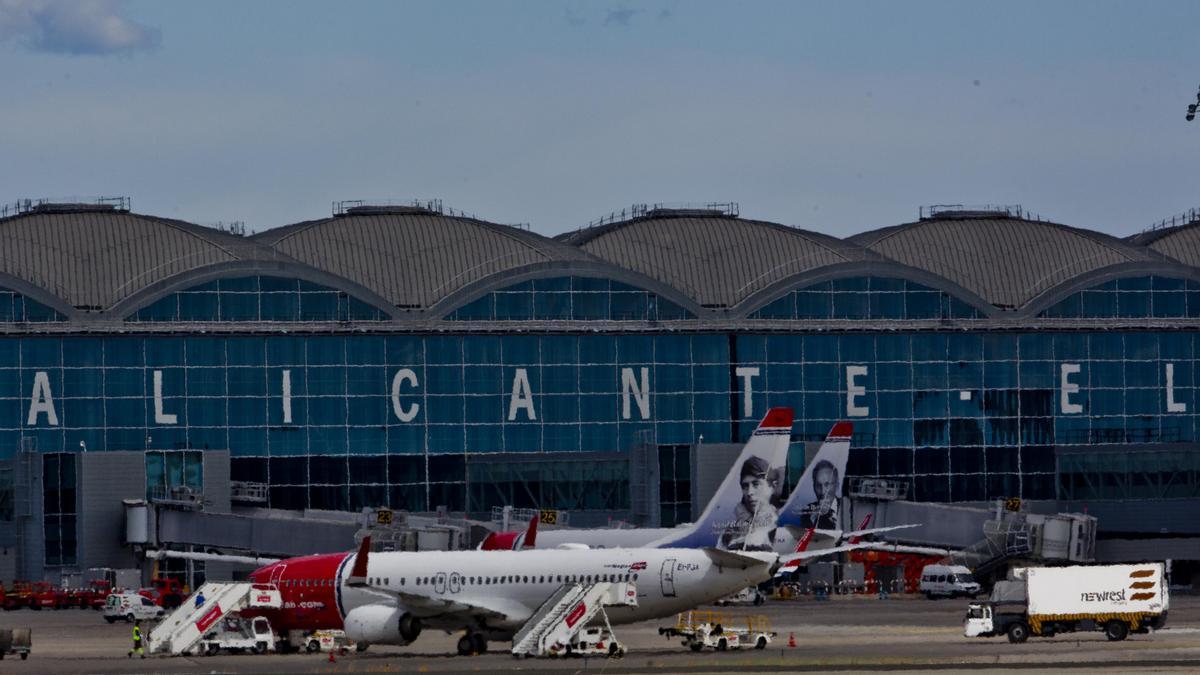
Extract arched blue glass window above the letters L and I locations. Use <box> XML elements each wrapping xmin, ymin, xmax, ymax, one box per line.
<box><xmin>127</xmin><ymin>276</ymin><xmax>388</xmax><ymax>322</ymax></box>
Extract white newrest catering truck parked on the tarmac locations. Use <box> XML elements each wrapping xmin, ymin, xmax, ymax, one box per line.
<box><xmin>962</xmin><ymin>562</ymin><xmax>1170</xmax><ymax>643</ymax></box>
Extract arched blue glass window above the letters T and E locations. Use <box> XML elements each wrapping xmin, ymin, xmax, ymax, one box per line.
<box><xmin>750</xmin><ymin>276</ymin><xmax>982</xmax><ymax>321</ymax></box>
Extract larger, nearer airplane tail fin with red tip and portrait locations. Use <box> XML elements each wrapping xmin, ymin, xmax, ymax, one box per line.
<box><xmin>649</xmin><ymin>408</ymin><xmax>792</xmax><ymax>550</ymax></box>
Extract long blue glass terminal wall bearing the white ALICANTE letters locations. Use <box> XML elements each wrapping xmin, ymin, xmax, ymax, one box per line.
<box><xmin>0</xmin><ymin>329</ymin><xmax>1200</xmax><ymax>509</ymax></box>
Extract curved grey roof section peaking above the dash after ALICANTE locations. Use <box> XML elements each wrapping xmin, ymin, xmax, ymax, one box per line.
<box><xmin>850</xmin><ymin>213</ymin><xmax>1159</xmax><ymax>309</ymax></box>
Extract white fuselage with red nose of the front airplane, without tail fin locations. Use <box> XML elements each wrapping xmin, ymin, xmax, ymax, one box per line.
<box><xmin>246</xmin><ymin>537</ymin><xmax>804</xmax><ymax>655</ymax></box>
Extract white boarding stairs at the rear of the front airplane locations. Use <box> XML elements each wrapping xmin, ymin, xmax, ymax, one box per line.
<box><xmin>512</xmin><ymin>581</ymin><xmax>637</xmax><ymax>656</ymax></box>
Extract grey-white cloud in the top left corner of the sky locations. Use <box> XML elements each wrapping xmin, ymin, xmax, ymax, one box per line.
<box><xmin>0</xmin><ymin>0</ymin><xmax>162</xmax><ymax>55</ymax></box>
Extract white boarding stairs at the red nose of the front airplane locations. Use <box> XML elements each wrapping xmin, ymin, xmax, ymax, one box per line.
<box><xmin>146</xmin><ymin>581</ymin><xmax>283</xmax><ymax>653</ymax></box>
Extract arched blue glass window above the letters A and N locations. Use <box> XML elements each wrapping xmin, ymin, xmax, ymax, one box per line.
<box><xmin>446</xmin><ymin>276</ymin><xmax>695</xmax><ymax>321</ymax></box>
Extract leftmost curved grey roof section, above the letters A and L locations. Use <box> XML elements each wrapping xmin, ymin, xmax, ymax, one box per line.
<box><xmin>0</xmin><ymin>207</ymin><xmax>265</xmax><ymax>311</ymax></box>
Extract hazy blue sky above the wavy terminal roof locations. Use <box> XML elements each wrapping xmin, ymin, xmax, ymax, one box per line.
<box><xmin>0</xmin><ymin>0</ymin><xmax>1200</xmax><ymax>237</ymax></box>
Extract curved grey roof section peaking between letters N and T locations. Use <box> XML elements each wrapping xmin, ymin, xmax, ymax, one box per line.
<box><xmin>562</xmin><ymin>209</ymin><xmax>878</xmax><ymax>307</ymax></box>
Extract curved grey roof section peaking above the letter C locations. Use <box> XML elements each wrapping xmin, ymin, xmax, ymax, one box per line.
<box><xmin>254</xmin><ymin>208</ymin><xmax>594</xmax><ymax>310</ymax></box>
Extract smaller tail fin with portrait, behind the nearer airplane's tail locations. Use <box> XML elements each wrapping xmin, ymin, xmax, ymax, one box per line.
<box><xmin>779</xmin><ymin>422</ymin><xmax>854</xmax><ymax>531</ymax></box>
